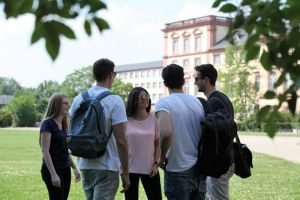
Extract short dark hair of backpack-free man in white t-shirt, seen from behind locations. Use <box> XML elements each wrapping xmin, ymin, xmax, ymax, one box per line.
<box><xmin>162</xmin><ymin>64</ymin><xmax>184</xmax><ymax>89</ymax></box>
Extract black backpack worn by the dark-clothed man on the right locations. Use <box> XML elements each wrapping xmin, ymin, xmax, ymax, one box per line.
<box><xmin>198</xmin><ymin>96</ymin><xmax>237</xmax><ymax>178</ymax></box>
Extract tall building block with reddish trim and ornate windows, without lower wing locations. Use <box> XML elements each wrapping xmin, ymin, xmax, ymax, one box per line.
<box><xmin>163</xmin><ymin>16</ymin><xmax>230</xmax><ymax>95</ymax></box>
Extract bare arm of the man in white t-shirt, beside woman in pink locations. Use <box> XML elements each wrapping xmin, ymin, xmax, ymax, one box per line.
<box><xmin>155</xmin><ymin>111</ymin><xmax>173</xmax><ymax>167</ymax></box>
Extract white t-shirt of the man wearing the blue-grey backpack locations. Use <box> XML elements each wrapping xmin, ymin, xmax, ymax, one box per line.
<box><xmin>70</xmin><ymin>86</ymin><xmax>127</xmax><ymax>171</ymax></box>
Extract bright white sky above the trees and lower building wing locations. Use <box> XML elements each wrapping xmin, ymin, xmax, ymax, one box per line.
<box><xmin>0</xmin><ymin>0</ymin><xmax>226</xmax><ymax>87</ymax></box>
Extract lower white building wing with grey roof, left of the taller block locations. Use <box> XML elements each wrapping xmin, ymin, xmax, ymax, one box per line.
<box><xmin>115</xmin><ymin>60</ymin><xmax>164</xmax><ymax>104</ymax></box>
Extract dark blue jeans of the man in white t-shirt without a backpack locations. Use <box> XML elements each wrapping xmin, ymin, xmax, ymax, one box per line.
<box><xmin>164</xmin><ymin>166</ymin><xmax>205</xmax><ymax>200</ymax></box>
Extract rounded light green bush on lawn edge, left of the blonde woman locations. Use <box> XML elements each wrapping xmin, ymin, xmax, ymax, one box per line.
<box><xmin>9</xmin><ymin>95</ymin><xmax>38</xmax><ymax>127</ymax></box>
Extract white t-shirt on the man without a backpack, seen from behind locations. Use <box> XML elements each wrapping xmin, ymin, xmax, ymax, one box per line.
<box><xmin>155</xmin><ymin>93</ymin><xmax>204</xmax><ymax>172</ymax></box>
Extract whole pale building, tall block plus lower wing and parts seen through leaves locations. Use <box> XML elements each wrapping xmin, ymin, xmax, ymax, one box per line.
<box><xmin>117</xmin><ymin>15</ymin><xmax>300</xmax><ymax>112</ymax></box>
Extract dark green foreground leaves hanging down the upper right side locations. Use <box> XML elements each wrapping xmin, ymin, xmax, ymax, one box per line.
<box><xmin>213</xmin><ymin>0</ymin><xmax>300</xmax><ymax>137</ymax></box>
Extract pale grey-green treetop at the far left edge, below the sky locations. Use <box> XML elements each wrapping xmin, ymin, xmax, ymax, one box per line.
<box><xmin>0</xmin><ymin>77</ymin><xmax>22</xmax><ymax>96</ymax></box>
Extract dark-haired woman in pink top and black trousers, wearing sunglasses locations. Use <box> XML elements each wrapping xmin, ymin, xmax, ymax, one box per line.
<box><xmin>125</xmin><ymin>87</ymin><xmax>162</xmax><ymax>200</ymax></box>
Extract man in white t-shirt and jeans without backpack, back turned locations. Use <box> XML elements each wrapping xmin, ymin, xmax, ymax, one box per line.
<box><xmin>155</xmin><ymin>64</ymin><xmax>205</xmax><ymax>200</ymax></box>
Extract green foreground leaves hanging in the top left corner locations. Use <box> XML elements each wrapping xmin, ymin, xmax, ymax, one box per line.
<box><xmin>0</xmin><ymin>0</ymin><xmax>109</xmax><ymax>60</ymax></box>
